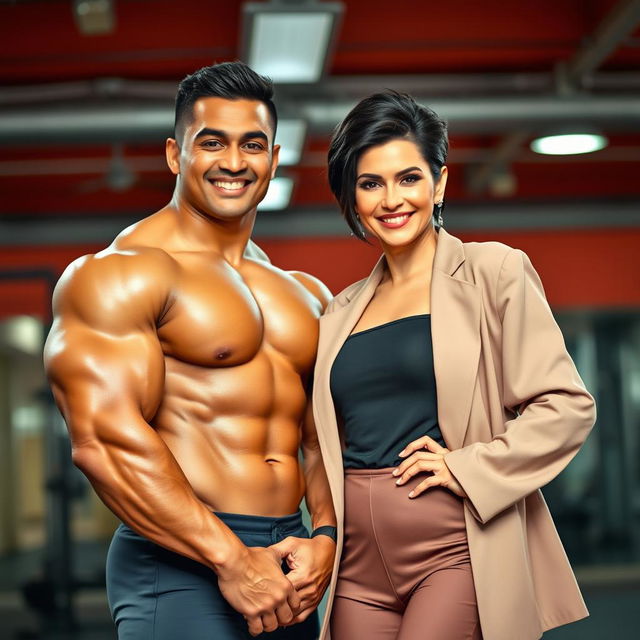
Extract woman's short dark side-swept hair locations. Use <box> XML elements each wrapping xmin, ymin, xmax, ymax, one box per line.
<box><xmin>329</xmin><ymin>90</ymin><xmax>449</xmax><ymax>240</ymax></box>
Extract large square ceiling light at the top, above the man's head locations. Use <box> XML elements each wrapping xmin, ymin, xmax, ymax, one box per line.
<box><xmin>242</xmin><ymin>0</ymin><xmax>343</xmax><ymax>83</ymax></box>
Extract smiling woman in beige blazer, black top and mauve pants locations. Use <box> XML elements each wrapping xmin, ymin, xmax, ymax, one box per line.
<box><xmin>314</xmin><ymin>92</ymin><xmax>595</xmax><ymax>640</ymax></box>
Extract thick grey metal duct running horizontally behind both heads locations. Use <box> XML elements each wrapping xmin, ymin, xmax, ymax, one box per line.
<box><xmin>0</xmin><ymin>94</ymin><xmax>640</xmax><ymax>146</ymax></box>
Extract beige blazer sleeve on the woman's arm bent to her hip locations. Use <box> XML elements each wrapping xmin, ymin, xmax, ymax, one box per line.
<box><xmin>445</xmin><ymin>249</ymin><xmax>595</xmax><ymax>523</ymax></box>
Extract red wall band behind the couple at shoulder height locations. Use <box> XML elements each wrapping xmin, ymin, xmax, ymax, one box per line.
<box><xmin>0</xmin><ymin>228</ymin><xmax>640</xmax><ymax>318</ymax></box>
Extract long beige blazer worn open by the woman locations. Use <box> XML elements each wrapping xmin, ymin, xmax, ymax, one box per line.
<box><xmin>313</xmin><ymin>230</ymin><xmax>595</xmax><ymax>640</ymax></box>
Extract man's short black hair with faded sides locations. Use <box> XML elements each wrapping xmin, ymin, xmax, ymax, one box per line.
<box><xmin>174</xmin><ymin>62</ymin><xmax>278</xmax><ymax>141</ymax></box>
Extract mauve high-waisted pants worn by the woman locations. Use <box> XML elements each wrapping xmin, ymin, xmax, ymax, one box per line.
<box><xmin>331</xmin><ymin>469</ymin><xmax>482</xmax><ymax>640</ymax></box>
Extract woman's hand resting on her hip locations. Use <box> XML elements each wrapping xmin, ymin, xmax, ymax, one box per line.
<box><xmin>393</xmin><ymin>436</ymin><xmax>467</xmax><ymax>498</ymax></box>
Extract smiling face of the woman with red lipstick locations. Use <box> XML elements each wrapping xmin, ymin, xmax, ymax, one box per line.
<box><xmin>355</xmin><ymin>139</ymin><xmax>447</xmax><ymax>248</ymax></box>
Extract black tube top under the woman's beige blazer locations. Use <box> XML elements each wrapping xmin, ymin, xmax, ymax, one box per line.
<box><xmin>331</xmin><ymin>315</ymin><xmax>445</xmax><ymax>469</ymax></box>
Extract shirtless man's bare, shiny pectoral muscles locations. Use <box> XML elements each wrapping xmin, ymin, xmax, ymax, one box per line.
<box><xmin>157</xmin><ymin>258</ymin><xmax>321</xmax><ymax>374</ymax></box>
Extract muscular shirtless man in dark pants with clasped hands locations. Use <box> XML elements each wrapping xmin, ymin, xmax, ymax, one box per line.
<box><xmin>45</xmin><ymin>63</ymin><xmax>335</xmax><ymax>640</ymax></box>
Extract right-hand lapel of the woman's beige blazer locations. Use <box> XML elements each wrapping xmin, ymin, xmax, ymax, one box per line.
<box><xmin>431</xmin><ymin>229</ymin><xmax>482</xmax><ymax>449</ymax></box>
